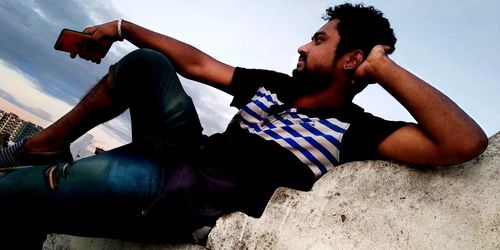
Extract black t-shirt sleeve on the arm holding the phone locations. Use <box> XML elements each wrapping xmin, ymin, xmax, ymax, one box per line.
<box><xmin>229</xmin><ymin>67</ymin><xmax>290</xmax><ymax>108</ymax></box>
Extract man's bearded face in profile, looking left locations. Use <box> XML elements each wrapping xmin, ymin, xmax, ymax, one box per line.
<box><xmin>293</xmin><ymin>20</ymin><xmax>340</xmax><ymax>94</ymax></box>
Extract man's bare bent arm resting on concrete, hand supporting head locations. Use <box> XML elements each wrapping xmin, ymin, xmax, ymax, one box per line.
<box><xmin>357</xmin><ymin>46</ymin><xmax>488</xmax><ymax>165</ymax></box>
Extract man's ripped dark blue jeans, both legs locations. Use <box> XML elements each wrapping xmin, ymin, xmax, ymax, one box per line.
<box><xmin>0</xmin><ymin>49</ymin><xmax>206</xmax><ymax>244</ymax></box>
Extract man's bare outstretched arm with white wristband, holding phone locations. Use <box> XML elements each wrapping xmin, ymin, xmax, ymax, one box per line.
<box><xmin>80</xmin><ymin>21</ymin><xmax>234</xmax><ymax>92</ymax></box>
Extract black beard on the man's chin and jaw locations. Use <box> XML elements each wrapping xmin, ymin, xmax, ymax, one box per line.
<box><xmin>291</xmin><ymin>68</ymin><xmax>331</xmax><ymax>97</ymax></box>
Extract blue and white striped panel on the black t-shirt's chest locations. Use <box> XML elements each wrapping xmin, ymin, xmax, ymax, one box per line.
<box><xmin>237</xmin><ymin>88</ymin><xmax>349</xmax><ymax>178</ymax></box>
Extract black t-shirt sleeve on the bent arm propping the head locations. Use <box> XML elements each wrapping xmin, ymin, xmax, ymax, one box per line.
<box><xmin>340</xmin><ymin>113</ymin><xmax>409</xmax><ymax>163</ymax></box>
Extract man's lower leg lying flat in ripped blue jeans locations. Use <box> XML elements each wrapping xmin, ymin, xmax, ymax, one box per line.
<box><xmin>0</xmin><ymin>140</ymin><xmax>203</xmax><ymax>242</ymax></box>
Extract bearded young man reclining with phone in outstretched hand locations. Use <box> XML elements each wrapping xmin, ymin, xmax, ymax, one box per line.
<box><xmin>0</xmin><ymin>4</ymin><xmax>487</xmax><ymax>248</ymax></box>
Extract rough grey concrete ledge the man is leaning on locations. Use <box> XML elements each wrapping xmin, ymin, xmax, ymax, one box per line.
<box><xmin>45</xmin><ymin>133</ymin><xmax>500</xmax><ymax>249</ymax></box>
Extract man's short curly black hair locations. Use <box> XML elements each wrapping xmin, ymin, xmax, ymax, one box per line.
<box><xmin>323</xmin><ymin>3</ymin><xmax>397</xmax><ymax>58</ymax></box>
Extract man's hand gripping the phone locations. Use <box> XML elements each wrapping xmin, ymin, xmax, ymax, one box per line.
<box><xmin>70</xmin><ymin>21</ymin><xmax>119</xmax><ymax>64</ymax></box>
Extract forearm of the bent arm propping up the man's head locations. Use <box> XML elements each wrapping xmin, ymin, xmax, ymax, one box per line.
<box><xmin>375</xmin><ymin>58</ymin><xmax>486</xmax><ymax>161</ymax></box>
